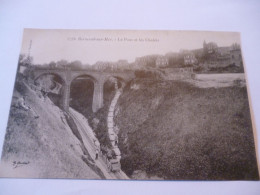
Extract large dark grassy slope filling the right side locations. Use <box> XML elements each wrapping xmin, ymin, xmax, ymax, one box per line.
<box><xmin>116</xmin><ymin>80</ymin><xmax>258</xmax><ymax>180</ymax></box>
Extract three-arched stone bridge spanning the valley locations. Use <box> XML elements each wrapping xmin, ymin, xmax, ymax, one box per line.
<box><xmin>31</xmin><ymin>68</ymin><xmax>135</xmax><ymax>112</ymax></box>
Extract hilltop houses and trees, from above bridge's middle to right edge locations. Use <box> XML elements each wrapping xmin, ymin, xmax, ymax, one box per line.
<box><xmin>93</xmin><ymin>41</ymin><xmax>244</xmax><ymax>73</ymax></box>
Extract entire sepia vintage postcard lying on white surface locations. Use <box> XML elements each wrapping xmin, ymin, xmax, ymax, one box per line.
<box><xmin>0</xmin><ymin>29</ymin><xmax>259</xmax><ymax>180</ymax></box>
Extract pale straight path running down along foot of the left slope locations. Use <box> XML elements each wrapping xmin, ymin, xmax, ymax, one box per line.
<box><xmin>69</xmin><ymin>108</ymin><xmax>129</xmax><ymax>179</ymax></box>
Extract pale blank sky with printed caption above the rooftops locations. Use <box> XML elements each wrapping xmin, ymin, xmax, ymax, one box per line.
<box><xmin>21</xmin><ymin>29</ymin><xmax>240</xmax><ymax>64</ymax></box>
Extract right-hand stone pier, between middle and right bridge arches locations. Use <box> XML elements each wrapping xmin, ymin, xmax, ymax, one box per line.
<box><xmin>92</xmin><ymin>81</ymin><xmax>104</xmax><ymax>112</ymax></box>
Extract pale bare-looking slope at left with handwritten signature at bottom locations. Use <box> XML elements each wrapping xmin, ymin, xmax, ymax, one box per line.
<box><xmin>1</xmin><ymin>79</ymin><xmax>100</xmax><ymax>179</ymax></box>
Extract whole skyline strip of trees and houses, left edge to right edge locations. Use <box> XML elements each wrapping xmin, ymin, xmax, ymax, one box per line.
<box><xmin>19</xmin><ymin>41</ymin><xmax>244</xmax><ymax>73</ymax></box>
